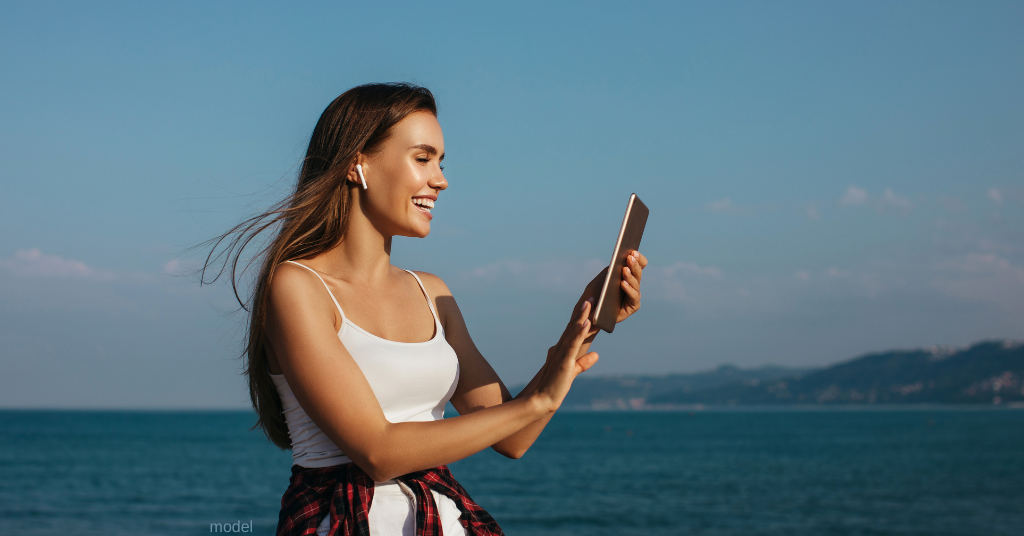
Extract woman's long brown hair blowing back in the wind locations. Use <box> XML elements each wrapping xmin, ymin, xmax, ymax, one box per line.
<box><xmin>200</xmin><ymin>83</ymin><xmax>437</xmax><ymax>449</ymax></box>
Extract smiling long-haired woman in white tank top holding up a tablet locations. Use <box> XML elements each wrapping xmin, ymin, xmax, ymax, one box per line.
<box><xmin>206</xmin><ymin>84</ymin><xmax>647</xmax><ymax>536</ymax></box>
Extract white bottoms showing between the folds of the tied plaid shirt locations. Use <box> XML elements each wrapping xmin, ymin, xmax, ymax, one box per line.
<box><xmin>316</xmin><ymin>479</ymin><xmax>466</xmax><ymax>536</ymax></box>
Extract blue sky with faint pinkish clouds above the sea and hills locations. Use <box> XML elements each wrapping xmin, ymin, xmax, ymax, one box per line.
<box><xmin>0</xmin><ymin>2</ymin><xmax>1024</xmax><ymax>407</ymax></box>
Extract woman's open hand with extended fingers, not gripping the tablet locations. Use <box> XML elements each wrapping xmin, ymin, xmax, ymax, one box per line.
<box><xmin>532</xmin><ymin>298</ymin><xmax>598</xmax><ymax>413</ymax></box>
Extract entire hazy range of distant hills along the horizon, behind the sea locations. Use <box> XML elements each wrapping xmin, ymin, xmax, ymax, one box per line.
<box><xmin>501</xmin><ymin>341</ymin><xmax>1024</xmax><ymax>410</ymax></box>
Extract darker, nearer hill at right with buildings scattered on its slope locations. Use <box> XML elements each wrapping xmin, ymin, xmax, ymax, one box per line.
<box><xmin>644</xmin><ymin>341</ymin><xmax>1024</xmax><ymax>407</ymax></box>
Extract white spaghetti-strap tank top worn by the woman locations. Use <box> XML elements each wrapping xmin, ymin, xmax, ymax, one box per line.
<box><xmin>270</xmin><ymin>260</ymin><xmax>459</xmax><ymax>467</ymax></box>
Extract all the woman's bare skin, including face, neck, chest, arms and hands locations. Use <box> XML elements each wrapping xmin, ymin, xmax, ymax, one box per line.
<box><xmin>267</xmin><ymin>112</ymin><xmax>647</xmax><ymax>482</ymax></box>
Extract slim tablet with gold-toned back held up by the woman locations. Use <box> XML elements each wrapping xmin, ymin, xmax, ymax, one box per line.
<box><xmin>591</xmin><ymin>194</ymin><xmax>650</xmax><ymax>333</ymax></box>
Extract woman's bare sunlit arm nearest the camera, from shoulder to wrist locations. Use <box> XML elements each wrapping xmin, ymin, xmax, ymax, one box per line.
<box><xmin>266</xmin><ymin>264</ymin><xmax>585</xmax><ymax>482</ymax></box>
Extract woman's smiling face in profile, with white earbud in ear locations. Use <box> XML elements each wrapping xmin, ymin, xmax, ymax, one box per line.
<box><xmin>348</xmin><ymin>112</ymin><xmax>447</xmax><ymax>238</ymax></box>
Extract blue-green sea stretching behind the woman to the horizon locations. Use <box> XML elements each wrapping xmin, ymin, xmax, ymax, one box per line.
<box><xmin>0</xmin><ymin>407</ymin><xmax>1024</xmax><ymax>536</ymax></box>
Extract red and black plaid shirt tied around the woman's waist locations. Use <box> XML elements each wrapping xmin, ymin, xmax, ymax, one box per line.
<box><xmin>278</xmin><ymin>463</ymin><xmax>504</xmax><ymax>536</ymax></box>
